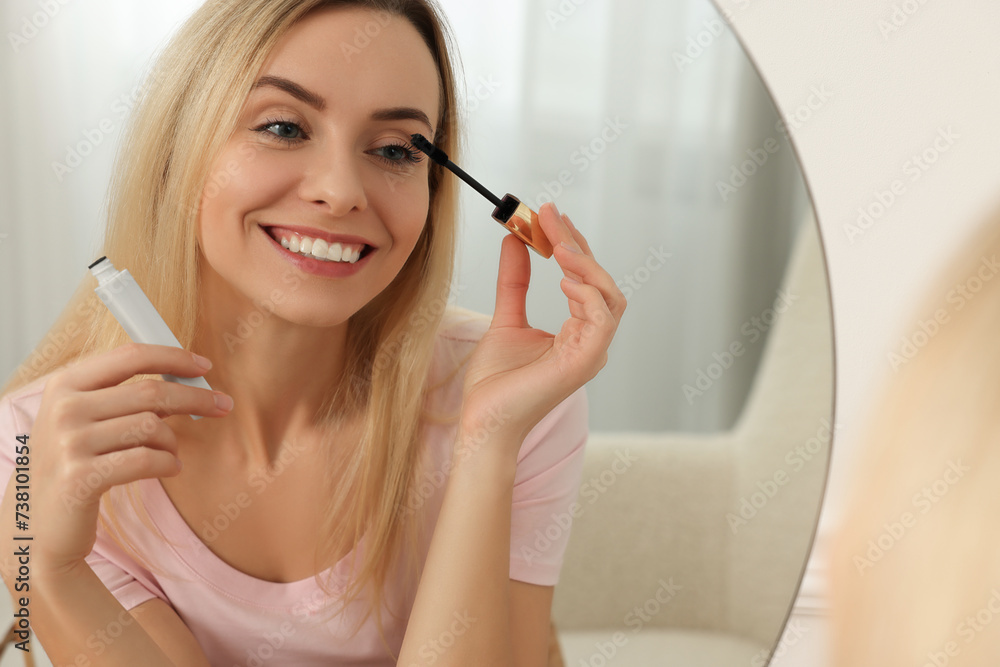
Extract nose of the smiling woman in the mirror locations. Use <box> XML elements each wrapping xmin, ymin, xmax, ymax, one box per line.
<box><xmin>299</xmin><ymin>147</ymin><xmax>368</xmax><ymax>216</ymax></box>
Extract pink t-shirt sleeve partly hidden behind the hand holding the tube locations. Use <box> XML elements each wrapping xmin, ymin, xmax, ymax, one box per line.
<box><xmin>0</xmin><ymin>392</ymin><xmax>166</xmax><ymax>610</ymax></box>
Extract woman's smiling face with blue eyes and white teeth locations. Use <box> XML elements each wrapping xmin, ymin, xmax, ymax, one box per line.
<box><xmin>198</xmin><ymin>8</ymin><xmax>439</xmax><ymax>327</ymax></box>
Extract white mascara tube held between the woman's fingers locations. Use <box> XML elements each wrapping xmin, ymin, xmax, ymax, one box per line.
<box><xmin>89</xmin><ymin>257</ymin><xmax>212</xmax><ymax>419</ymax></box>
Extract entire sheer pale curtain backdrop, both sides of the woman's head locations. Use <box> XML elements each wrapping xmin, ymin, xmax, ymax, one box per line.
<box><xmin>0</xmin><ymin>0</ymin><xmax>807</xmax><ymax>431</ymax></box>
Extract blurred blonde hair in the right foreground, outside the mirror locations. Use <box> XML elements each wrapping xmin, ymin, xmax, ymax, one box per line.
<box><xmin>830</xmin><ymin>201</ymin><xmax>1000</xmax><ymax>667</ymax></box>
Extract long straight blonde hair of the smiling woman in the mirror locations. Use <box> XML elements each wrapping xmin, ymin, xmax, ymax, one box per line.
<box><xmin>3</xmin><ymin>0</ymin><xmax>468</xmax><ymax>653</ymax></box>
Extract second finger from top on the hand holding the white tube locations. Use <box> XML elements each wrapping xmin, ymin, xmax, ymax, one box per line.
<box><xmin>79</xmin><ymin>378</ymin><xmax>231</xmax><ymax>421</ymax></box>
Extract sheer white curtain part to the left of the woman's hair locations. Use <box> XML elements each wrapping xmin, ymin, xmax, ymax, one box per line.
<box><xmin>0</xmin><ymin>0</ymin><xmax>206</xmax><ymax>392</ymax></box>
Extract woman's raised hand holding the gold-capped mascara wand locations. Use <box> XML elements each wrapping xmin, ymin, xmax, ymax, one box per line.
<box><xmin>462</xmin><ymin>204</ymin><xmax>626</xmax><ymax>457</ymax></box>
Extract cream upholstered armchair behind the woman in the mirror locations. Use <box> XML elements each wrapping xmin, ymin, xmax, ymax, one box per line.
<box><xmin>553</xmin><ymin>219</ymin><xmax>834</xmax><ymax>667</ymax></box>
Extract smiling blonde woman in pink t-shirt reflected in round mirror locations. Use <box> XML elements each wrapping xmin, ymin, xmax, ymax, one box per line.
<box><xmin>0</xmin><ymin>0</ymin><xmax>625</xmax><ymax>666</ymax></box>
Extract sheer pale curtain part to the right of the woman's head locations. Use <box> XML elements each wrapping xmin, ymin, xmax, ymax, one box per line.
<box><xmin>443</xmin><ymin>0</ymin><xmax>809</xmax><ymax>431</ymax></box>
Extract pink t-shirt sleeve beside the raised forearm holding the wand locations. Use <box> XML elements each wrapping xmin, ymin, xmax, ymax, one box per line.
<box><xmin>510</xmin><ymin>387</ymin><xmax>589</xmax><ymax>586</ymax></box>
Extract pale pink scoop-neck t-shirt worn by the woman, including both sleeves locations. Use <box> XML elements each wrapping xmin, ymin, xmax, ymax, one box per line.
<box><xmin>0</xmin><ymin>308</ymin><xmax>588</xmax><ymax>667</ymax></box>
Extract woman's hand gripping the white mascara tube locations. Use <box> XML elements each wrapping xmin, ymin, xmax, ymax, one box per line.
<box><xmin>24</xmin><ymin>343</ymin><xmax>229</xmax><ymax>572</ymax></box>
